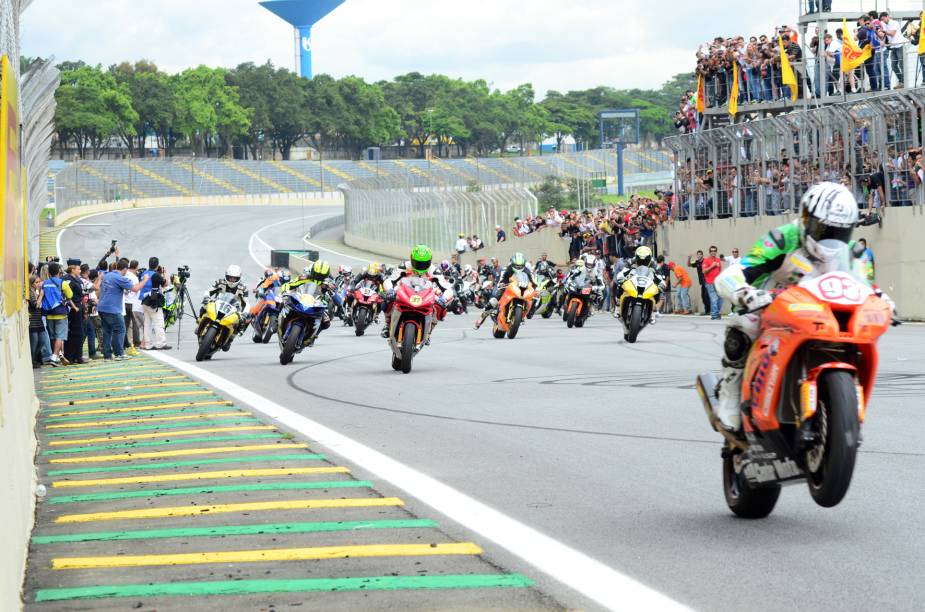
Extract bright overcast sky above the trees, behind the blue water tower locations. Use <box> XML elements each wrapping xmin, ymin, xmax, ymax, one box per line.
<box><xmin>21</xmin><ymin>0</ymin><xmax>797</xmax><ymax>97</ymax></box>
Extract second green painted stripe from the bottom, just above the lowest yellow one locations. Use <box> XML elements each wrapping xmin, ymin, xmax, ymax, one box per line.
<box><xmin>32</xmin><ymin>519</ymin><xmax>439</xmax><ymax>544</ymax></box>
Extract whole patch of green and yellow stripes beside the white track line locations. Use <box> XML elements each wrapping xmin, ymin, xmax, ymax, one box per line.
<box><xmin>26</xmin><ymin>357</ymin><xmax>533</xmax><ymax>608</ymax></box>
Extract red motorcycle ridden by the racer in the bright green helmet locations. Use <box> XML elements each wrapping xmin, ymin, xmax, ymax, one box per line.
<box><xmin>389</xmin><ymin>276</ymin><xmax>437</xmax><ymax>374</ymax></box>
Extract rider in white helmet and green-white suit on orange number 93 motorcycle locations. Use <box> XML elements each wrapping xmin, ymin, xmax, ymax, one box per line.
<box><xmin>716</xmin><ymin>182</ymin><xmax>880</xmax><ymax>431</ymax></box>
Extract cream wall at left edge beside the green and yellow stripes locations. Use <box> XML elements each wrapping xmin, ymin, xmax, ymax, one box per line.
<box><xmin>0</xmin><ymin>308</ymin><xmax>38</xmax><ymax>610</ymax></box>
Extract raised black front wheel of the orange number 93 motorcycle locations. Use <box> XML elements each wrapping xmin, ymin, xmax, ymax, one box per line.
<box><xmin>807</xmin><ymin>370</ymin><xmax>860</xmax><ymax>508</ymax></box>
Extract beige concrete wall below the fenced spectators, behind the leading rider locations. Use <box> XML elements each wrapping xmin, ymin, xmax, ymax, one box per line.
<box><xmin>664</xmin><ymin>206</ymin><xmax>925</xmax><ymax>320</ymax></box>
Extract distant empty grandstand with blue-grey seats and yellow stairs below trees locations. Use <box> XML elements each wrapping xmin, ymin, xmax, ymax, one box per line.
<box><xmin>49</xmin><ymin>150</ymin><xmax>672</xmax><ymax>209</ymax></box>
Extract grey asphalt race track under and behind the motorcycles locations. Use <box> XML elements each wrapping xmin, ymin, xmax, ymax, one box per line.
<box><xmin>61</xmin><ymin>207</ymin><xmax>925</xmax><ymax>611</ymax></box>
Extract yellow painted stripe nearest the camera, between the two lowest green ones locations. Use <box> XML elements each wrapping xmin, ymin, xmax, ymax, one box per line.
<box><xmin>51</xmin><ymin>542</ymin><xmax>482</xmax><ymax>570</ymax></box>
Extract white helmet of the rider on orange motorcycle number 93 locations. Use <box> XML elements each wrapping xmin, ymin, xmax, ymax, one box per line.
<box><xmin>800</xmin><ymin>182</ymin><xmax>858</xmax><ymax>261</ymax></box>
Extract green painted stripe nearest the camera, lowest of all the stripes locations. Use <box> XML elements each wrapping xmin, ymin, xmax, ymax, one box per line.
<box><xmin>35</xmin><ymin>574</ymin><xmax>534</xmax><ymax>602</ymax></box>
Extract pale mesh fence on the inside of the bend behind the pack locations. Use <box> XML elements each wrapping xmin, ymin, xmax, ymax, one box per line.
<box><xmin>340</xmin><ymin>182</ymin><xmax>537</xmax><ymax>258</ymax></box>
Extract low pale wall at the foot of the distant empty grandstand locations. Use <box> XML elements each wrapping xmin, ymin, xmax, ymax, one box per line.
<box><xmin>55</xmin><ymin>192</ymin><xmax>344</xmax><ymax>227</ymax></box>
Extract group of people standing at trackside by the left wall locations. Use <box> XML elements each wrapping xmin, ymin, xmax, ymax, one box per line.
<box><xmin>29</xmin><ymin>246</ymin><xmax>172</xmax><ymax>368</ymax></box>
